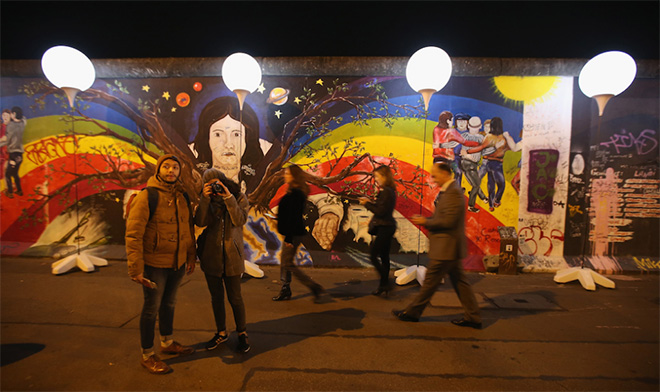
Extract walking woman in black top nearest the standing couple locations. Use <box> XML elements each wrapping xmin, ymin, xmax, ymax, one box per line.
<box><xmin>273</xmin><ymin>165</ymin><xmax>324</xmax><ymax>303</ymax></box>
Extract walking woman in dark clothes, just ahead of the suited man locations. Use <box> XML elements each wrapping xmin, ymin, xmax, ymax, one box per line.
<box><xmin>360</xmin><ymin>166</ymin><xmax>396</xmax><ymax>295</ymax></box>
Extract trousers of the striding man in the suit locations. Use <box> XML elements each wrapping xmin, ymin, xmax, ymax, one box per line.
<box><xmin>405</xmin><ymin>260</ymin><xmax>481</xmax><ymax>323</ymax></box>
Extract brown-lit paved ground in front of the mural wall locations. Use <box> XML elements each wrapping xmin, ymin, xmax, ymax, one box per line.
<box><xmin>0</xmin><ymin>258</ymin><xmax>660</xmax><ymax>391</ymax></box>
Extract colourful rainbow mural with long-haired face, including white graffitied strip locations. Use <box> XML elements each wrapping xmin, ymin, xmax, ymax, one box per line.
<box><xmin>0</xmin><ymin>71</ymin><xmax>658</xmax><ymax>270</ymax></box>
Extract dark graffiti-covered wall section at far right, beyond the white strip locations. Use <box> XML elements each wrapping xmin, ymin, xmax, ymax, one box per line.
<box><xmin>566</xmin><ymin>79</ymin><xmax>660</xmax><ymax>271</ymax></box>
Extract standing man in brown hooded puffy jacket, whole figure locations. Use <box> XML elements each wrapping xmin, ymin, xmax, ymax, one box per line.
<box><xmin>126</xmin><ymin>154</ymin><xmax>195</xmax><ymax>374</ymax></box>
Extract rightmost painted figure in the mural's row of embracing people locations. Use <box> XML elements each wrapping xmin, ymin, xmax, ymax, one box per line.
<box><xmin>467</xmin><ymin>117</ymin><xmax>509</xmax><ymax>212</ymax></box>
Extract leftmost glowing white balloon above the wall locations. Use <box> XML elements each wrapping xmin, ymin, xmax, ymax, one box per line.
<box><xmin>41</xmin><ymin>45</ymin><xmax>96</xmax><ymax>91</ymax></box>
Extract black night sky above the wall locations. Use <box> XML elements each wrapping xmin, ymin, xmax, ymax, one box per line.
<box><xmin>0</xmin><ymin>0</ymin><xmax>660</xmax><ymax>59</ymax></box>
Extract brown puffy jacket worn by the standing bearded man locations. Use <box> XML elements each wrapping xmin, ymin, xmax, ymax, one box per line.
<box><xmin>126</xmin><ymin>157</ymin><xmax>196</xmax><ymax>277</ymax></box>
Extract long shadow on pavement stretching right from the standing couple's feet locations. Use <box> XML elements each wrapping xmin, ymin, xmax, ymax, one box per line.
<box><xmin>165</xmin><ymin>308</ymin><xmax>366</xmax><ymax>365</ymax></box>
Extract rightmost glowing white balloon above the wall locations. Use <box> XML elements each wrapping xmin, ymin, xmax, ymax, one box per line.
<box><xmin>578</xmin><ymin>51</ymin><xmax>637</xmax><ymax>98</ymax></box>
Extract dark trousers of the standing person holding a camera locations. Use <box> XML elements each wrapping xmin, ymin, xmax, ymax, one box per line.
<box><xmin>204</xmin><ymin>274</ymin><xmax>246</xmax><ymax>333</ymax></box>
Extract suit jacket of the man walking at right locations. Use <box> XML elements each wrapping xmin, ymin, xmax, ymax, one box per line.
<box><xmin>424</xmin><ymin>181</ymin><xmax>467</xmax><ymax>260</ymax></box>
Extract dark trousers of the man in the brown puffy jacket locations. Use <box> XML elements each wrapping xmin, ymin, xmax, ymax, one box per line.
<box><xmin>140</xmin><ymin>265</ymin><xmax>186</xmax><ymax>350</ymax></box>
